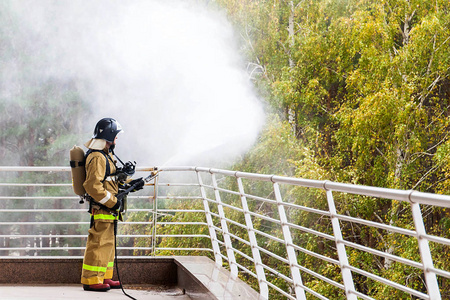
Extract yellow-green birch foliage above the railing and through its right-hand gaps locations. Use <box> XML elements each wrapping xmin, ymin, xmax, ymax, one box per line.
<box><xmin>212</xmin><ymin>0</ymin><xmax>450</xmax><ymax>299</ymax></box>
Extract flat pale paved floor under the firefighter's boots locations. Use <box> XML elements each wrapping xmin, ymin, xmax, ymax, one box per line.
<box><xmin>0</xmin><ymin>285</ymin><xmax>191</xmax><ymax>300</ymax></box>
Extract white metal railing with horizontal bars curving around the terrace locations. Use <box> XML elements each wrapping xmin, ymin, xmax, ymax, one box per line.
<box><xmin>0</xmin><ymin>167</ymin><xmax>450</xmax><ymax>300</ymax></box>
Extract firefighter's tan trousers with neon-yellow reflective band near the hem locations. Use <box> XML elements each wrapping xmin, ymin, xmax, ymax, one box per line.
<box><xmin>81</xmin><ymin>219</ymin><xmax>114</xmax><ymax>285</ymax></box>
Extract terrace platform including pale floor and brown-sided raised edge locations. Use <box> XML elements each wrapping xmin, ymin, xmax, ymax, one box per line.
<box><xmin>0</xmin><ymin>256</ymin><xmax>260</xmax><ymax>300</ymax></box>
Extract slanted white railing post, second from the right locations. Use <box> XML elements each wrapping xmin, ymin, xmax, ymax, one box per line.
<box><xmin>327</xmin><ymin>190</ymin><xmax>357</xmax><ymax>300</ymax></box>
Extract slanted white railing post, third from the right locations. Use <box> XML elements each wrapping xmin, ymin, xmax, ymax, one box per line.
<box><xmin>273</xmin><ymin>182</ymin><xmax>306</xmax><ymax>300</ymax></box>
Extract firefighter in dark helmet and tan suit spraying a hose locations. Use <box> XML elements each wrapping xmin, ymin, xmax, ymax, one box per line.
<box><xmin>81</xmin><ymin>118</ymin><xmax>144</xmax><ymax>291</ymax></box>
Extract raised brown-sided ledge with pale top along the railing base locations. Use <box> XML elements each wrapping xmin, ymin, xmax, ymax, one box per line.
<box><xmin>0</xmin><ymin>256</ymin><xmax>260</xmax><ymax>300</ymax></box>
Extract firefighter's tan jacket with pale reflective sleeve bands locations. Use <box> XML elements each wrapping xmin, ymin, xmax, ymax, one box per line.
<box><xmin>83</xmin><ymin>148</ymin><xmax>119</xmax><ymax>213</ymax></box>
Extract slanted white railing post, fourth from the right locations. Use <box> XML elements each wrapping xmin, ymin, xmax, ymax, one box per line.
<box><xmin>237</xmin><ymin>177</ymin><xmax>269</xmax><ymax>299</ymax></box>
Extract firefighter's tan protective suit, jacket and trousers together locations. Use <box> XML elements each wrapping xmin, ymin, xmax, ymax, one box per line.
<box><xmin>81</xmin><ymin>148</ymin><xmax>119</xmax><ymax>285</ymax></box>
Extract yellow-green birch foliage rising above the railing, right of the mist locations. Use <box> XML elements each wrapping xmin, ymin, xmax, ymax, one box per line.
<box><xmin>219</xmin><ymin>0</ymin><xmax>449</xmax><ymax>191</ymax></box>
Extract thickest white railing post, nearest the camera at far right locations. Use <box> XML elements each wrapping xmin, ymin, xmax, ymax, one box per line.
<box><xmin>411</xmin><ymin>203</ymin><xmax>441</xmax><ymax>300</ymax></box>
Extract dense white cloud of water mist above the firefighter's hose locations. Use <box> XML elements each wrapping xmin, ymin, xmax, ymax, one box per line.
<box><xmin>5</xmin><ymin>0</ymin><xmax>264</xmax><ymax>167</ymax></box>
